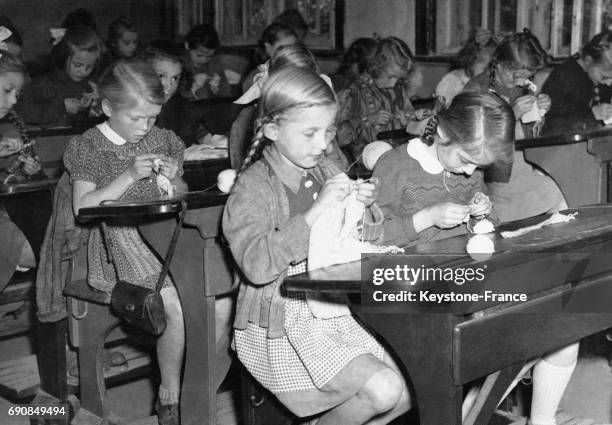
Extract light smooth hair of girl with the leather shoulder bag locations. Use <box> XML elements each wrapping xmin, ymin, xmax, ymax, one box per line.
<box><xmin>98</xmin><ymin>59</ymin><xmax>164</xmax><ymax>108</ymax></box>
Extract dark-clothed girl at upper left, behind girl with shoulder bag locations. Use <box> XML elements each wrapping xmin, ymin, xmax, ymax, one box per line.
<box><xmin>18</xmin><ymin>26</ymin><xmax>100</xmax><ymax>127</ymax></box>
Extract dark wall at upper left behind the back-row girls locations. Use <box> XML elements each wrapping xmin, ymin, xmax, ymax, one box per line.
<box><xmin>0</xmin><ymin>0</ymin><xmax>174</xmax><ymax>61</ymax></box>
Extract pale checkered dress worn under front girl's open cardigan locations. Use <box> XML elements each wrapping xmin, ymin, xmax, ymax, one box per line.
<box><xmin>234</xmin><ymin>172</ymin><xmax>384</xmax><ymax>416</ymax></box>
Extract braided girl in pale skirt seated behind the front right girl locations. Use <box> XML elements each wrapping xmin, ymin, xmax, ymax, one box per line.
<box><xmin>464</xmin><ymin>30</ymin><xmax>567</xmax><ymax>221</ymax></box>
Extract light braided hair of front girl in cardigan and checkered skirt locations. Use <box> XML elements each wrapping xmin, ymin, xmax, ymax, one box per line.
<box><xmin>239</xmin><ymin>66</ymin><xmax>336</xmax><ymax>173</ymax></box>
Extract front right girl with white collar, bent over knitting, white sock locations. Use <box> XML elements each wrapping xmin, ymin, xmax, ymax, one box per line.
<box><xmin>374</xmin><ymin>91</ymin><xmax>578</xmax><ymax>425</ymax></box>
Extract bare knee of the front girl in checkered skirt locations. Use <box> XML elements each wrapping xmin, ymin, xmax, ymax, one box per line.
<box><xmin>361</xmin><ymin>369</ymin><xmax>405</xmax><ymax>414</ymax></box>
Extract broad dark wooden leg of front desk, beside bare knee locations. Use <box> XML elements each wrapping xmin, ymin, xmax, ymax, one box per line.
<box><xmin>360</xmin><ymin>312</ymin><xmax>463</xmax><ymax>425</ymax></box>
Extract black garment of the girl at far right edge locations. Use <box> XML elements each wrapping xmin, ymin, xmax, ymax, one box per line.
<box><xmin>542</xmin><ymin>59</ymin><xmax>612</xmax><ymax>134</ymax></box>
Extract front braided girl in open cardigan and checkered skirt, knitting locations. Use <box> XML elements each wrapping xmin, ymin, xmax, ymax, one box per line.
<box><xmin>223</xmin><ymin>67</ymin><xmax>410</xmax><ymax>425</ymax></box>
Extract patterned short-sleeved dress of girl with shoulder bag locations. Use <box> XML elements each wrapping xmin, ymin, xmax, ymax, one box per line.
<box><xmin>64</xmin><ymin>127</ymin><xmax>185</xmax><ymax>292</ymax></box>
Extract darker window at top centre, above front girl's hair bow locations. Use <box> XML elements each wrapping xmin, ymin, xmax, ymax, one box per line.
<box><xmin>216</xmin><ymin>0</ymin><xmax>344</xmax><ymax>50</ymax></box>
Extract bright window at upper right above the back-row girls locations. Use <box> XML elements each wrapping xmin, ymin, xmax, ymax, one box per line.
<box><xmin>415</xmin><ymin>0</ymin><xmax>612</xmax><ymax>57</ymax></box>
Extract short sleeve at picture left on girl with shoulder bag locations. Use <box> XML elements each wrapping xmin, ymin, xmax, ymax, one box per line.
<box><xmin>64</xmin><ymin>136</ymin><xmax>103</xmax><ymax>185</ymax></box>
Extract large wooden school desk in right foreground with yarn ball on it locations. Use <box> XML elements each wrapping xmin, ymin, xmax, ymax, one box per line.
<box><xmin>284</xmin><ymin>204</ymin><xmax>612</xmax><ymax>425</ymax></box>
